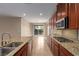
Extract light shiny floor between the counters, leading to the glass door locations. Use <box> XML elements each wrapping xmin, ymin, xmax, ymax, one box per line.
<box><xmin>32</xmin><ymin>36</ymin><xmax>52</xmax><ymax>56</ymax></box>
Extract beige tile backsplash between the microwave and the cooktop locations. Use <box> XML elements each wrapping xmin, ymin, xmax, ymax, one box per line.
<box><xmin>53</xmin><ymin>29</ymin><xmax>79</xmax><ymax>40</ymax></box>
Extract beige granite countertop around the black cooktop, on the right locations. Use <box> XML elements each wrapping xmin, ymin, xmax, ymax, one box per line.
<box><xmin>51</xmin><ymin>37</ymin><xmax>79</xmax><ymax>56</ymax></box>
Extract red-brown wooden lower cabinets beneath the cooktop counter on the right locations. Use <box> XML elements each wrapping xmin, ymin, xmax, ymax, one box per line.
<box><xmin>51</xmin><ymin>39</ymin><xmax>73</xmax><ymax>56</ymax></box>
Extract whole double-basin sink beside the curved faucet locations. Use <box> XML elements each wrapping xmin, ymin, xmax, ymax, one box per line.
<box><xmin>0</xmin><ymin>42</ymin><xmax>23</xmax><ymax>56</ymax></box>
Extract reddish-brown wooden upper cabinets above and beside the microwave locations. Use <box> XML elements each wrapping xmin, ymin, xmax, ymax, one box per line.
<box><xmin>53</xmin><ymin>3</ymin><xmax>79</xmax><ymax>29</ymax></box>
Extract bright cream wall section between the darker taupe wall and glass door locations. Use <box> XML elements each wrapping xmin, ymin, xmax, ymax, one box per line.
<box><xmin>21</xmin><ymin>18</ymin><xmax>32</xmax><ymax>37</ymax></box>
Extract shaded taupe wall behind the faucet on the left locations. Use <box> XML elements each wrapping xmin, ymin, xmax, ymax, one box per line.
<box><xmin>0</xmin><ymin>16</ymin><xmax>21</xmax><ymax>46</ymax></box>
